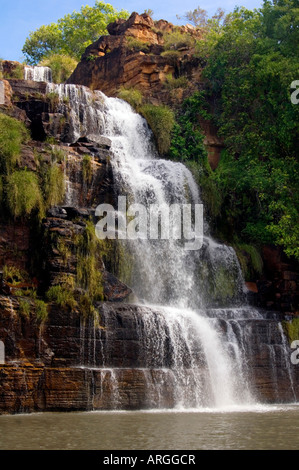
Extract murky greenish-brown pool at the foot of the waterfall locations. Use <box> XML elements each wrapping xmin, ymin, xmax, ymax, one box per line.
<box><xmin>0</xmin><ymin>405</ymin><xmax>299</xmax><ymax>450</ymax></box>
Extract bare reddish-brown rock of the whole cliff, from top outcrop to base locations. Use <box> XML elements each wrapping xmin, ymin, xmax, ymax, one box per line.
<box><xmin>0</xmin><ymin>46</ymin><xmax>299</xmax><ymax>413</ymax></box>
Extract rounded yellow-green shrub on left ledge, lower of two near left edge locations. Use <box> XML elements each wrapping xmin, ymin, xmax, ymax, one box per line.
<box><xmin>6</xmin><ymin>170</ymin><xmax>44</xmax><ymax>218</ymax></box>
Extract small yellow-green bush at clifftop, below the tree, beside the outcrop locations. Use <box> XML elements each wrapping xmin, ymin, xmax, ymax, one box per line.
<box><xmin>39</xmin><ymin>53</ymin><xmax>78</xmax><ymax>83</ymax></box>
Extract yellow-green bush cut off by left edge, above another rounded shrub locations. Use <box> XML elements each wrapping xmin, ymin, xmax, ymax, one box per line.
<box><xmin>0</xmin><ymin>113</ymin><xmax>29</xmax><ymax>173</ymax></box>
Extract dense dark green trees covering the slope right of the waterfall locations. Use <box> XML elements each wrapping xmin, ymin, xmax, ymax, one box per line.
<box><xmin>170</xmin><ymin>0</ymin><xmax>299</xmax><ymax>262</ymax></box>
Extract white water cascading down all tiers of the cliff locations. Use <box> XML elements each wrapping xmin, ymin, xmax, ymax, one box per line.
<box><xmin>44</xmin><ymin>84</ymin><xmax>296</xmax><ymax>408</ymax></box>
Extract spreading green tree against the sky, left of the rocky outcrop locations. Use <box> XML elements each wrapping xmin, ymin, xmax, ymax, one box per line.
<box><xmin>22</xmin><ymin>0</ymin><xmax>129</xmax><ymax>65</ymax></box>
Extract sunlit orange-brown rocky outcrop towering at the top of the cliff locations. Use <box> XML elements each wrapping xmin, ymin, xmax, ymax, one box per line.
<box><xmin>67</xmin><ymin>13</ymin><xmax>203</xmax><ymax>104</ymax></box>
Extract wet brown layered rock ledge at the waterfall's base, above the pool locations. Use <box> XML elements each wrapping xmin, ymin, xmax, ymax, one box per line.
<box><xmin>0</xmin><ymin>296</ymin><xmax>299</xmax><ymax>413</ymax></box>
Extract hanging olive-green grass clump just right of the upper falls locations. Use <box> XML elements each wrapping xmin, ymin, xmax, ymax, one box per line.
<box><xmin>140</xmin><ymin>104</ymin><xmax>175</xmax><ymax>155</ymax></box>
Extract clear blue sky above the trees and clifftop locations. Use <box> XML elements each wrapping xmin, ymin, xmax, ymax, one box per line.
<box><xmin>0</xmin><ymin>0</ymin><xmax>262</xmax><ymax>61</ymax></box>
